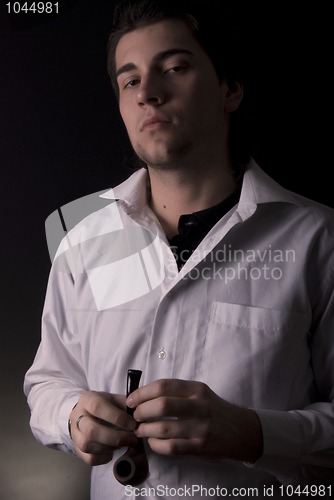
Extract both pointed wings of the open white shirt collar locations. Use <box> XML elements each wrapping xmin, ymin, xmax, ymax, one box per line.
<box><xmin>100</xmin><ymin>159</ymin><xmax>301</xmax><ymax>220</ymax></box>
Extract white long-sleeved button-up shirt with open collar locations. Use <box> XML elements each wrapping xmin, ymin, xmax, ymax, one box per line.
<box><xmin>25</xmin><ymin>160</ymin><xmax>334</xmax><ymax>500</ymax></box>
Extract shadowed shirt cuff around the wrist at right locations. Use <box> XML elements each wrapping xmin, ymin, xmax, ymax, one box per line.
<box><xmin>246</xmin><ymin>409</ymin><xmax>302</xmax><ymax>477</ymax></box>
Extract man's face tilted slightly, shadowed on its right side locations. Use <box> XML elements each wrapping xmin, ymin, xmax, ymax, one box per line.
<box><xmin>116</xmin><ymin>20</ymin><xmax>234</xmax><ymax>168</ymax></box>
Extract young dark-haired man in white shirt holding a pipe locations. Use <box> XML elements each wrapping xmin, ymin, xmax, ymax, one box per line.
<box><xmin>26</xmin><ymin>0</ymin><xmax>334</xmax><ymax>500</ymax></box>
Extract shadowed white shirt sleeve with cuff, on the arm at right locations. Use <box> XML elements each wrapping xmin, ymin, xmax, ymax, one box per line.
<box><xmin>252</xmin><ymin>274</ymin><xmax>334</xmax><ymax>485</ymax></box>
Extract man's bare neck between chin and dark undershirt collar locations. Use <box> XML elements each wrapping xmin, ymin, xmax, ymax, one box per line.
<box><xmin>148</xmin><ymin>161</ymin><xmax>237</xmax><ymax>239</ymax></box>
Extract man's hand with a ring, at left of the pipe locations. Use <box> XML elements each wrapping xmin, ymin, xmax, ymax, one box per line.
<box><xmin>70</xmin><ymin>391</ymin><xmax>138</xmax><ymax>465</ymax></box>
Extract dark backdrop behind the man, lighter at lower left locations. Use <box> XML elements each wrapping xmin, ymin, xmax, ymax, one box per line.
<box><xmin>0</xmin><ymin>0</ymin><xmax>334</xmax><ymax>500</ymax></box>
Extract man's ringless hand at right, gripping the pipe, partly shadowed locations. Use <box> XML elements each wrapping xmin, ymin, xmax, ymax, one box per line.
<box><xmin>126</xmin><ymin>379</ymin><xmax>263</xmax><ymax>463</ymax></box>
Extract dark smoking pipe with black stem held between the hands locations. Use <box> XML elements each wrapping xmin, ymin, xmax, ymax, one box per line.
<box><xmin>114</xmin><ymin>370</ymin><xmax>149</xmax><ymax>486</ymax></box>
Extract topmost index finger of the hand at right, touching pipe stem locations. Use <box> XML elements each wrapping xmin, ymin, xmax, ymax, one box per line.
<box><xmin>126</xmin><ymin>379</ymin><xmax>204</xmax><ymax>408</ymax></box>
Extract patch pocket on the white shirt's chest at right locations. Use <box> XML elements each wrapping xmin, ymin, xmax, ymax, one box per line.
<box><xmin>202</xmin><ymin>302</ymin><xmax>310</xmax><ymax>409</ymax></box>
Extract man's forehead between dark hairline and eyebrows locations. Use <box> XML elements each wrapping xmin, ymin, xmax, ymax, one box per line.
<box><xmin>115</xmin><ymin>19</ymin><xmax>205</xmax><ymax>70</ymax></box>
